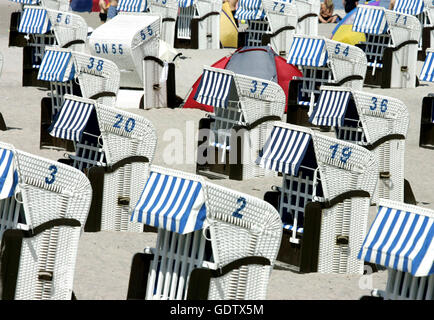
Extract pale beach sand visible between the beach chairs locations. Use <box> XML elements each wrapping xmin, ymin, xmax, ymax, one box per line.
<box><xmin>0</xmin><ymin>1</ymin><xmax>434</xmax><ymax>300</ymax></box>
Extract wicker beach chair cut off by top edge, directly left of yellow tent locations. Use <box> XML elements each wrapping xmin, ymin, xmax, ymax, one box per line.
<box><xmin>175</xmin><ymin>0</ymin><xmax>222</xmax><ymax>49</ymax></box>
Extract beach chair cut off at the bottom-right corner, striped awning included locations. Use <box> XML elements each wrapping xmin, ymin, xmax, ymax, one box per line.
<box><xmin>359</xmin><ymin>199</ymin><xmax>434</xmax><ymax>300</ymax></box>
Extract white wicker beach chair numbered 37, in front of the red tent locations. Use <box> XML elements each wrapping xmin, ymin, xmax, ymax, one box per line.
<box><xmin>194</xmin><ymin>67</ymin><xmax>285</xmax><ymax>180</ymax></box>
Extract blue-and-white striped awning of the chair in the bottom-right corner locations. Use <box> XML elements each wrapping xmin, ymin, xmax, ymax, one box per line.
<box><xmin>358</xmin><ymin>203</ymin><xmax>434</xmax><ymax>276</ymax></box>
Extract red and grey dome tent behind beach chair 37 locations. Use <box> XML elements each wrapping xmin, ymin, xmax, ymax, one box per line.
<box><xmin>184</xmin><ymin>46</ymin><xmax>302</xmax><ymax>112</ymax></box>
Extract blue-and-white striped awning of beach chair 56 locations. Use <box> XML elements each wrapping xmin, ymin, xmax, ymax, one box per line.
<box><xmin>18</xmin><ymin>8</ymin><xmax>51</xmax><ymax>34</ymax></box>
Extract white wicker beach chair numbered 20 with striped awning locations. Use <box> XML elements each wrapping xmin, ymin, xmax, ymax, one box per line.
<box><xmin>49</xmin><ymin>95</ymin><xmax>157</xmax><ymax>232</ymax></box>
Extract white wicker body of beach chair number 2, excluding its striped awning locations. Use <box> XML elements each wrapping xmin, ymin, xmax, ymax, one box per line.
<box><xmin>127</xmin><ymin>166</ymin><xmax>282</xmax><ymax>300</ymax></box>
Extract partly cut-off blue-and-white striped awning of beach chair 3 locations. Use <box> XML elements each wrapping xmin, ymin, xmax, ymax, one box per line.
<box><xmin>0</xmin><ymin>148</ymin><xmax>18</xmax><ymax>199</ymax></box>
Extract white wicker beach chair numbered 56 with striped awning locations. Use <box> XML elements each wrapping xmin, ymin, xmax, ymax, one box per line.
<box><xmin>14</xmin><ymin>6</ymin><xmax>87</xmax><ymax>86</ymax></box>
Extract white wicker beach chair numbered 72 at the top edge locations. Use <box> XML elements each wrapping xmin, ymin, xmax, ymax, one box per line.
<box><xmin>235</xmin><ymin>0</ymin><xmax>297</xmax><ymax>57</ymax></box>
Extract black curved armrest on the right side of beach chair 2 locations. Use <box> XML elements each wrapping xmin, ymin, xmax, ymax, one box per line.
<box><xmin>187</xmin><ymin>256</ymin><xmax>271</xmax><ymax>300</ymax></box>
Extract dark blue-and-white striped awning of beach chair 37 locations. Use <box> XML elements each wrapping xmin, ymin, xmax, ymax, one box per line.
<box><xmin>194</xmin><ymin>69</ymin><xmax>233</xmax><ymax>108</ymax></box>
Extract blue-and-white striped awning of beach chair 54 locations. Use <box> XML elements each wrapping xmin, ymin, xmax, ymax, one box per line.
<box><xmin>287</xmin><ymin>37</ymin><xmax>328</xmax><ymax>67</ymax></box>
